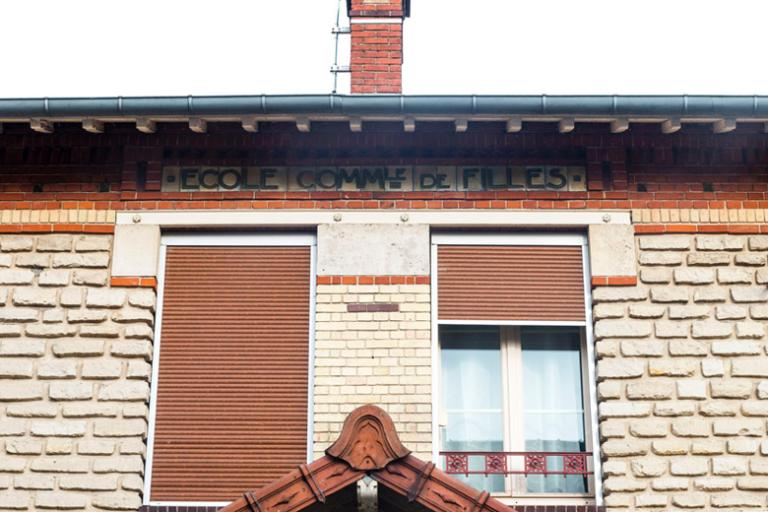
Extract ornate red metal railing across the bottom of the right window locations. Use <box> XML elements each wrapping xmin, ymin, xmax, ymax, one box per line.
<box><xmin>440</xmin><ymin>452</ymin><xmax>592</xmax><ymax>476</ymax></box>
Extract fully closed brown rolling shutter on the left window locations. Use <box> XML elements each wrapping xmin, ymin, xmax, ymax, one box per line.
<box><xmin>150</xmin><ymin>246</ymin><xmax>310</xmax><ymax>501</ymax></box>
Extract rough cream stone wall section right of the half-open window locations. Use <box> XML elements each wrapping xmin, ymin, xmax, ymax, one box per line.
<box><xmin>593</xmin><ymin>235</ymin><xmax>768</xmax><ymax>511</ymax></box>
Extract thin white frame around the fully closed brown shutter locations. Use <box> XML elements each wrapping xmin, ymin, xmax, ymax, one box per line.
<box><xmin>142</xmin><ymin>233</ymin><xmax>317</xmax><ymax>507</ymax></box>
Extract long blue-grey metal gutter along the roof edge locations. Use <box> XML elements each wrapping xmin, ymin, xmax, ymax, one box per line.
<box><xmin>0</xmin><ymin>95</ymin><xmax>768</xmax><ymax>121</ymax></box>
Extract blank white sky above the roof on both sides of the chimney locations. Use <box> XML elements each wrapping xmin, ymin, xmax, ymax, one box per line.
<box><xmin>0</xmin><ymin>0</ymin><xmax>768</xmax><ymax>97</ymax></box>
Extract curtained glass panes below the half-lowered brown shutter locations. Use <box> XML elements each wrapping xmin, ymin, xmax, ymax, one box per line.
<box><xmin>439</xmin><ymin>325</ymin><xmax>589</xmax><ymax>495</ymax></box>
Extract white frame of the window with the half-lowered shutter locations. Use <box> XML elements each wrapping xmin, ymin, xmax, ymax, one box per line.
<box><xmin>431</xmin><ymin>233</ymin><xmax>603</xmax><ymax>505</ymax></box>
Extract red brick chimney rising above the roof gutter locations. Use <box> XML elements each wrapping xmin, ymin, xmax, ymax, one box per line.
<box><xmin>347</xmin><ymin>0</ymin><xmax>411</xmax><ymax>94</ymax></box>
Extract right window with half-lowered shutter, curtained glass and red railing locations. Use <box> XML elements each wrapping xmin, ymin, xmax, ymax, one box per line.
<box><xmin>433</xmin><ymin>235</ymin><xmax>599</xmax><ymax>499</ymax></box>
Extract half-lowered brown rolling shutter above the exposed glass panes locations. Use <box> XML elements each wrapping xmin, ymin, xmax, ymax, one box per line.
<box><xmin>437</xmin><ymin>245</ymin><xmax>585</xmax><ymax>321</ymax></box>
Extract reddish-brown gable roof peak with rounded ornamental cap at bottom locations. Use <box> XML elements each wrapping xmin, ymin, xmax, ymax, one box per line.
<box><xmin>220</xmin><ymin>405</ymin><xmax>515</xmax><ymax>512</ymax></box>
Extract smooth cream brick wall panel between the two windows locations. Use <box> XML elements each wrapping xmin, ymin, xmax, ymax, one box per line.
<box><xmin>314</xmin><ymin>285</ymin><xmax>432</xmax><ymax>460</ymax></box>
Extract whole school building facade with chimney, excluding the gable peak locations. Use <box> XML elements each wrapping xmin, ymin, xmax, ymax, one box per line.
<box><xmin>0</xmin><ymin>0</ymin><xmax>768</xmax><ymax>511</ymax></box>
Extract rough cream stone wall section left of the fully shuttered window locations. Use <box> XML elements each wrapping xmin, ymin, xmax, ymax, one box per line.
<box><xmin>0</xmin><ymin>234</ymin><xmax>155</xmax><ymax>510</ymax></box>
